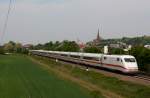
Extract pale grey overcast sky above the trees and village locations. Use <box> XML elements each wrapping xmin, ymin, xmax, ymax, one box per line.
<box><xmin>0</xmin><ymin>0</ymin><xmax>150</xmax><ymax>44</ymax></box>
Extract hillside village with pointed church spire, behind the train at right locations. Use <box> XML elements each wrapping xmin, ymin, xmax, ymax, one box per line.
<box><xmin>82</xmin><ymin>29</ymin><xmax>150</xmax><ymax>51</ymax></box>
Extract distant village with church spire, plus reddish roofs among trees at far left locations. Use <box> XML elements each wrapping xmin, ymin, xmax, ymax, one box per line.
<box><xmin>10</xmin><ymin>29</ymin><xmax>150</xmax><ymax>51</ymax></box>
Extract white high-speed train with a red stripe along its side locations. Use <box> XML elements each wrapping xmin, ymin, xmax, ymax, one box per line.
<box><xmin>30</xmin><ymin>50</ymin><xmax>138</xmax><ymax>73</ymax></box>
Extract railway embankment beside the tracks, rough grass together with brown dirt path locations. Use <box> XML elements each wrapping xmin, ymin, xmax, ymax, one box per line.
<box><xmin>31</xmin><ymin>56</ymin><xmax>150</xmax><ymax>98</ymax></box>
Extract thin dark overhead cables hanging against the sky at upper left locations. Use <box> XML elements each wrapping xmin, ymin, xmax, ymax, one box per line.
<box><xmin>0</xmin><ymin>0</ymin><xmax>12</xmax><ymax>45</ymax></box>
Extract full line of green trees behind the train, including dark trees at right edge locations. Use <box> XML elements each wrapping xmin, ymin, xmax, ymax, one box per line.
<box><xmin>0</xmin><ymin>40</ymin><xmax>150</xmax><ymax>73</ymax></box>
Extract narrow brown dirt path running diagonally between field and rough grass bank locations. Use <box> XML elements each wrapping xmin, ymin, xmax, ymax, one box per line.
<box><xmin>29</xmin><ymin>57</ymin><xmax>123</xmax><ymax>98</ymax></box>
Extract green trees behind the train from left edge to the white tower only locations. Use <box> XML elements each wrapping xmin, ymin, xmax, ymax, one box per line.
<box><xmin>0</xmin><ymin>40</ymin><xmax>102</xmax><ymax>54</ymax></box>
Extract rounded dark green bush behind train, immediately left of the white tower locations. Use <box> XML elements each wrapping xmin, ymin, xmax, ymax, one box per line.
<box><xmin>83</xmin><ymin>46</ymin><xmax>102</xmax><ymax>53</ymax></box>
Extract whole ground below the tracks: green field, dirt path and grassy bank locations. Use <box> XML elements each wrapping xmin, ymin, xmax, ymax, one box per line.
<box><xmin>0</xmin><ymin>55</ymin><xmax>150</xmax><ymax>98</ymax></box>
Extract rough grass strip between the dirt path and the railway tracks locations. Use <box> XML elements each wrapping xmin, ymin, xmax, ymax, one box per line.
<box><xmin>34</xmin><ymin>57</ymin><xmax>150</xmax><ymax>98</ymax></box>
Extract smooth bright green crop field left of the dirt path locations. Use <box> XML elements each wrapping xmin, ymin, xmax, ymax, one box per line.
<box><xmin>0</xmin><ymin>55</ymin><xmax>96</xmax><ymax>98</ymax></box>
